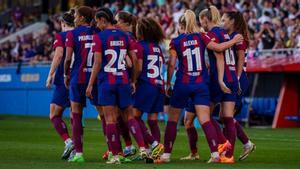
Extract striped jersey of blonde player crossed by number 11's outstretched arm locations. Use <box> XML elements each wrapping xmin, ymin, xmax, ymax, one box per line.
<box><xmin>207</xmin><ymin>27</ymin><xmax>237</xmax><ymax>82</ymax></box>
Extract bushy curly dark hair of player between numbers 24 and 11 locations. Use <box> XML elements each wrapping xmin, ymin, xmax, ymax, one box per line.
<box><xmin>137</xmin><ymin>18</ymin><xmax>165</xmax><ymax>43</ymax></box>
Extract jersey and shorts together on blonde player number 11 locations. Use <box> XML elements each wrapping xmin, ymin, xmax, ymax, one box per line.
<box><xmin>170</xmin><ymin>33</ymin><xmax>209</xmax><ymax>109</ymax></box>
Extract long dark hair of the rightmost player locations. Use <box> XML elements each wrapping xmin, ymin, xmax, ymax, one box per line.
<box><xmin>226</xmin><ymin>11</ymin><xmax>249</xmax><ymax>45</ymax></box>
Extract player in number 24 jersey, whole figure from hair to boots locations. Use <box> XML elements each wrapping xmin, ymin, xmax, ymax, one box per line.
<box><xmin>86</xmin><ymin>8</ymin><xmax>147</xmax><ymax>164</ymax></box>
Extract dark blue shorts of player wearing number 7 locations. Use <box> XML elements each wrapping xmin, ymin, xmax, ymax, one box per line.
<box><xmin>70</xmin><ymin>84</ymin><xmax>99</xmax><ymax>106</ymax></box>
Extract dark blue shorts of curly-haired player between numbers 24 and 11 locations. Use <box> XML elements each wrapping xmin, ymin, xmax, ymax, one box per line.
<box><xmin>134</xmin><ymin>82</ymin><xmax>165</xmax><ymax>113</ymax></box>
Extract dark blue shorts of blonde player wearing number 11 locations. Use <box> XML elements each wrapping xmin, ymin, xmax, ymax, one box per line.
<box><xmin>170</xmin><ymin>83</ymin><xmax>210</xmax><ymax>109</ymax></box>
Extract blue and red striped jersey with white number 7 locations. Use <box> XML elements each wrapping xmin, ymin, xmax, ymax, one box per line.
<box><xmin>66</xmin><ymin>26</ymin><xmax>97</xmax><ymax>84</ymax></box>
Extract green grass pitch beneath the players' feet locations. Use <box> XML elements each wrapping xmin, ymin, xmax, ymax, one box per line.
<box><xmin>0</xmin><ymin>116</ymin><xmax>300</xmax><ymax>169</ymax></box>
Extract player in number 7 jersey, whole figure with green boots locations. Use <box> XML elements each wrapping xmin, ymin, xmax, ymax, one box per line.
<box><xmin>64</xmin><ymin>6</ymin><xmax>100</xmax><ymax>163</ymax></box>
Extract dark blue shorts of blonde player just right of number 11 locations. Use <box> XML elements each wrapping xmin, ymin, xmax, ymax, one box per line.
<box><xmin>209</xmin><ymin>82</ymin><xmax>238</xmax><ymax>104</ymax></box>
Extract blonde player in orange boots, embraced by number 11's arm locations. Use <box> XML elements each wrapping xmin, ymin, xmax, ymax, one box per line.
<box><xmin>199</xmin><ymin>6</ymin><xmax>238</xmax><ymax>163</ymax></box>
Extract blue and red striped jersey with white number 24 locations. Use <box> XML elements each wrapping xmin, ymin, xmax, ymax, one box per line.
<box><xmin>93</xmin><ymin>29</ymin><xmax>134</xmax><ymax>85</ymax></box>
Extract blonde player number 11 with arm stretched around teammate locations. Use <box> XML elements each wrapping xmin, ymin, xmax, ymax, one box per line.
<box><xmin>156</xmin><ymin>10</ymin><xmax>244</xmax><ymax>163</ymax></box>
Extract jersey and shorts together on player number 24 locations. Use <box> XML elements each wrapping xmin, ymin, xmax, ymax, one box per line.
<box><xmin>93</xmin><ymin>29</ymin><xmax>131</xmax><ymax>108</ymax></box>
